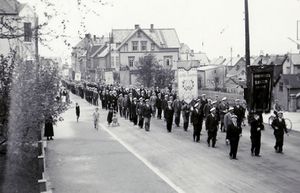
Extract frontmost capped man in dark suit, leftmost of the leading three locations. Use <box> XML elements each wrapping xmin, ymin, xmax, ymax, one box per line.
<box><xmin>227</xmin><ymin>115</ymin><xmax>242</xmax><ymax>159</ymax></box>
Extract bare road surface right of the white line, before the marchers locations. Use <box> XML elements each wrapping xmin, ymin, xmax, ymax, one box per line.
<box><xmin>46</xmin><ymin>93</ymin><xmax>300</xmax><ymax>193</ymax></box>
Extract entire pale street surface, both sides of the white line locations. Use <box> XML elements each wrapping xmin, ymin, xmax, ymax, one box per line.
<box><xmin>47</xmin><ymin>95</ymin><xmax>300</xmax><ymax>193</ymax></box>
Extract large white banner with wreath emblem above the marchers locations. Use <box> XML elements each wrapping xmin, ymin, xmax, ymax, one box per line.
<box><xmin>177</xmin><ymin>68</ymin><xmax>198</xmax><ymax>103</ymax></box>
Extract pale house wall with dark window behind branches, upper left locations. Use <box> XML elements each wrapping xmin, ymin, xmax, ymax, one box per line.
<box><xmin>0</xmin><ymin>0</ymin><xmax>38</xmax><ymax>61</ymax></box>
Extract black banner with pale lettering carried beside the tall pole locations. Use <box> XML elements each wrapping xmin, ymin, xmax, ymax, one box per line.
<box><xmin>249</xmin><ymin>65</ymin><xmax>273</xmax><ymax>113</ymax></box>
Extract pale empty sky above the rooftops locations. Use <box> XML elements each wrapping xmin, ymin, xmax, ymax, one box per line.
<box><xmin>20</xmin><ymin>0</ymin><xmax>300</xmax><ymax>62</ymax></box>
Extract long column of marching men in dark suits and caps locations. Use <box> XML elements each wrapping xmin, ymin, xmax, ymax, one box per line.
<box><xmin>63</xmin><ymin>81</ymin><xmax>287</xmax><ymax>159</ymax></box>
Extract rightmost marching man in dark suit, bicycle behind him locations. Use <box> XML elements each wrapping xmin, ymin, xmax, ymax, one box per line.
<box><xmin>271</xmin><ymin>111</ymin><xmax>288</xmax><ymax>153</ymax></box>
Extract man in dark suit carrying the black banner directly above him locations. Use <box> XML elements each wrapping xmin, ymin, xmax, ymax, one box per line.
<box><xmin>250</xmin><ymin>113</ymin><xmax>264</xmax><ymax>157</ymax></box>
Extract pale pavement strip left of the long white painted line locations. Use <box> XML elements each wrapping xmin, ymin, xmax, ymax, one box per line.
<box><xmin>46</xmin><ymin>95</ymin><xmax>176</xmax><ymax>193</ymax></box>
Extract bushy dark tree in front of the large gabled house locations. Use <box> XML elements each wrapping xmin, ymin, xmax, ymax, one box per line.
<box><xmin>136</xmin><ymin>54</ymin><xmax>174</xmax><ymax>88</ymax></box>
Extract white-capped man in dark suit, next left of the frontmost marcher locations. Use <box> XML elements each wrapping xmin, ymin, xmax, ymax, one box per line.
<box><xmin>205</xmin><ymin>107</ymin><xmax>218</xmax><ymax>148</ymax></box>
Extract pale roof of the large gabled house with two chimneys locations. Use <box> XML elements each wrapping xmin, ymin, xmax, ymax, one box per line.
<box><xmin>112</xmin><ymin>28</ymin><xmax>180</xmax><ymax>48</ymax></box>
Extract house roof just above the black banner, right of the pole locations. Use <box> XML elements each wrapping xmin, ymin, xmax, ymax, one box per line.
<box><xmin>251</xmin><ymin>55</ymin><xmax>287</xmax><ymax>65</ymax></box>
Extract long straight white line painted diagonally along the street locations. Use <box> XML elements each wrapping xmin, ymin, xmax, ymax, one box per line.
<box><xmin>99</xmin><ymin>123</ymin><xmax>185</xmax><ymax>193</ymax></box>
